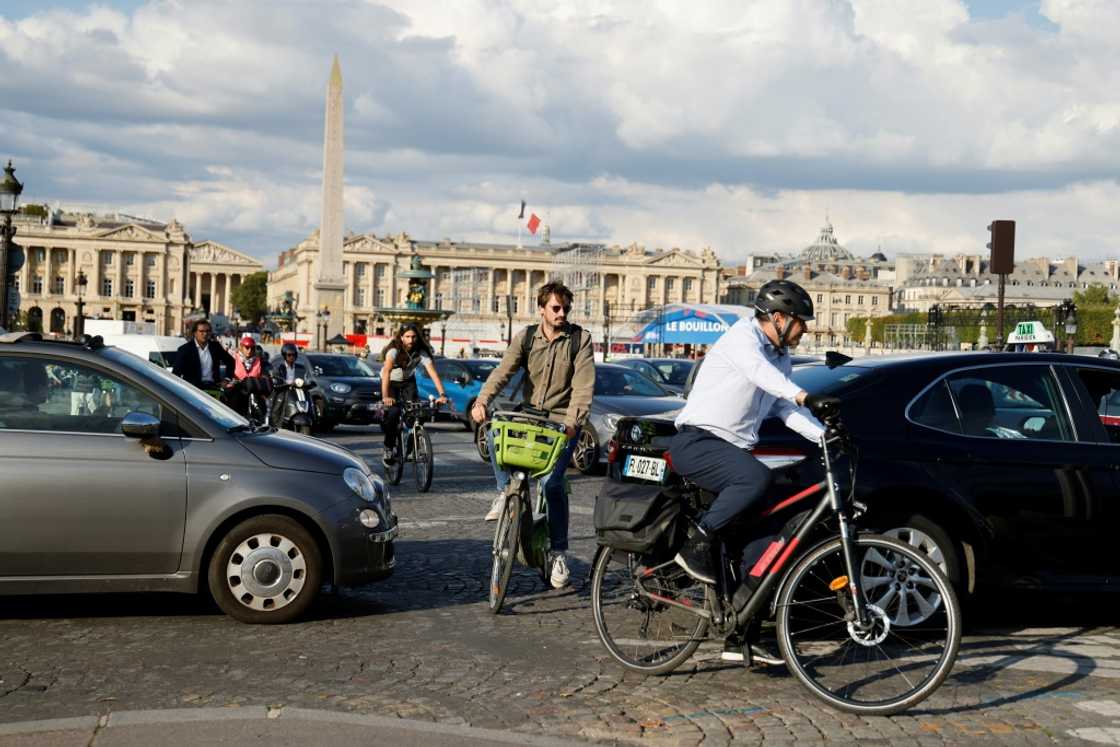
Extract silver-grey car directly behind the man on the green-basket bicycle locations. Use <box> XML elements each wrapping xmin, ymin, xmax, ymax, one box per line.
<box><xmin>475</xmin><ymin>363</ymin><xmax>684</xmax><ymax>475</ymax></box>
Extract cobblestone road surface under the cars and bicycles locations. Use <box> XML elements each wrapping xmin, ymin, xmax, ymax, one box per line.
<box><xmin>0</xmin><ymin>424</ymin><xmax>1120</xmax><ymax>745</ymax></box>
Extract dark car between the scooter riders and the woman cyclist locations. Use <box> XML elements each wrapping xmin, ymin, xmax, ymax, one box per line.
<box><xmin>307</xmin><ymin>353</ymin><xmax>381</xmax><ymax>430</ymax></box>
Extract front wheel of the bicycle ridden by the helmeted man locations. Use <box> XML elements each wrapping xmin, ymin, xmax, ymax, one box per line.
<box><xmin>777</xmin><ymin>535</ymin><xmax>961</xmax><ymax>716</ymax></box>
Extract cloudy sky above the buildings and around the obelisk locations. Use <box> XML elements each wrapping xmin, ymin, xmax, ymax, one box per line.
<box><xmin>0</xmin><ymin>0</ymin><xmax>1120</xmax><ymax>267</ymax></box>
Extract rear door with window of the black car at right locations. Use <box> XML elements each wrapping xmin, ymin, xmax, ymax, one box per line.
<box><xmin>946</xmin><ymin>362</ymin><xmax>1102</xmax><ymax>587</ymax></box>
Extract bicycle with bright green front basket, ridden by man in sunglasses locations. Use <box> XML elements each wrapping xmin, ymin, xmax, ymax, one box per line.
<box><xmin>489</xmin><ymin>411</ymin><xmax>568</xmax><ymax>615</ymax></box>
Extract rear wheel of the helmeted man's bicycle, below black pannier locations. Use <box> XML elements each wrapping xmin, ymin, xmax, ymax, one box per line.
<box><xmin>591</xmin><ymin>548</ymin><xmax>711</xmax><ymax>674</ymax></box>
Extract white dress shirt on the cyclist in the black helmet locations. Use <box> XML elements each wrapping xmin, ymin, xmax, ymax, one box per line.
<box><xmin>676</xmin><ymin>317</ymin><xmax>824</xmax><ymax>449</ymax></box>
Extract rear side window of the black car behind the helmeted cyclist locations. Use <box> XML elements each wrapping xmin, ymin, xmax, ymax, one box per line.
<box><xmin>948</xmin><ymin>365</ymin><xmax>1073</xmax><ymax>441</ymax></box>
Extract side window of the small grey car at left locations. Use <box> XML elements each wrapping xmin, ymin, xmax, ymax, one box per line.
<box><xmin>0</xmin><ymin>356</ymin><xmax>162</xmax><ymax>433</ymax></box>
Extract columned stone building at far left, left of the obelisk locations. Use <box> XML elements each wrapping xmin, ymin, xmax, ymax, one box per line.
<box><xmin>13</xmin><ymin>206</ymin><xmax>264</xmax><ymax>335</ymax></box>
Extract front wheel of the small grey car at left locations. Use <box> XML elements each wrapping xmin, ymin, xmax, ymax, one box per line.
<box><xmin>207</xmin><ymin>514</ymin><xmax>323</xmax><ymax>624</ymax></box>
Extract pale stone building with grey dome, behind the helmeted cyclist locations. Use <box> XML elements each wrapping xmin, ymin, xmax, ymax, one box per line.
<box><xmin>724</xmin><ymin>223</ymin><xmax>895</xmax><ymax>347</ymax></box>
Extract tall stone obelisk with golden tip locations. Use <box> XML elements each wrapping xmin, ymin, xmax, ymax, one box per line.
<box><xmin>315</xmin><ymin>55</ymin><xmax>346</xmax><ymax>349</ymax></box>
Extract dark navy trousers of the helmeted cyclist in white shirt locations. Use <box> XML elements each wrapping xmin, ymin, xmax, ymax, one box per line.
<box><xmin>669</xmin><ymin>426</ymin><xmax>772</xmax><ymax>532</ymax></box>
